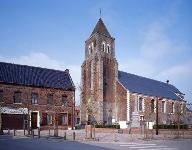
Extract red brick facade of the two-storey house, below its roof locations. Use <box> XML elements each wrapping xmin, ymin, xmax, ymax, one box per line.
<box><xmin>0</xmin><ymin>83</ymin><xmax>74</xmax><ymax>128</ymax></box>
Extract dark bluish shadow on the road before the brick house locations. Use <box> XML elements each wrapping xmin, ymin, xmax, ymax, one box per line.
<box><xmin>0</xmin><ymin>135</ymin><xmax>112</xmax><ymax>150</ymax></box>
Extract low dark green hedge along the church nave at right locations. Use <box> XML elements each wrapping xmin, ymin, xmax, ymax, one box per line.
<box><xmin>153</xmin><ymin>124</ymin><xmax>188</xmax><ymax>129</ymax></box>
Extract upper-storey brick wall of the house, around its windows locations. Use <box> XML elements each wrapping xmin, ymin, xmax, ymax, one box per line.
<box><xmin>0</xmin><ymin>84</ymin><xmax>74</xmax><ymax>125</ymax></box>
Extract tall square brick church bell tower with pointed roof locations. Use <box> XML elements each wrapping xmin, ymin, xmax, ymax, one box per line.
<box><xmin>81</xmin><ymin>18</ymin><xmax>118</xmax><ymax>124</ymax></box>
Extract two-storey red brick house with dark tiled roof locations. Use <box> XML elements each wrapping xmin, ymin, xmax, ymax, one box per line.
<box><xmin>0</xmin><ymin>62</ymin><xmax>75</xmax><ymax>129</ymax></box>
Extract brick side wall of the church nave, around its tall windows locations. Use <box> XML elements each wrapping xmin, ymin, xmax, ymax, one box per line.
<box><xmin>130</xmin><ymin>93</ymin><xmax>185</xmax><ymax>124</ymax></box>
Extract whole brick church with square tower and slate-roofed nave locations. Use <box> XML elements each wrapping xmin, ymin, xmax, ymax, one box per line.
<box><xmin>81</xmin><ymin>18</ymin><xmax>185</xmax><ymax>128</ymax></box>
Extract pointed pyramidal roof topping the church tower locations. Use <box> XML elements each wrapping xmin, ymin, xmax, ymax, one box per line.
<box><xmin>91</xmin><ymin>18</ymin><xmax>111</xmax><ymax>37</ymax></box>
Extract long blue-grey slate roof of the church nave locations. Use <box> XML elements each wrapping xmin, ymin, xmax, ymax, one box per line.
<box><xmin>118</xmin><ymin>71</ymin><xmax>182</xmax><ymax>100</ymax></box>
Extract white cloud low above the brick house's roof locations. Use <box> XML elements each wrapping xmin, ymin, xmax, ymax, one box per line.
<box><xmin>0</xmin><ymin>52</ymin><xmax>81</xmax><ymax>103</ymax></box>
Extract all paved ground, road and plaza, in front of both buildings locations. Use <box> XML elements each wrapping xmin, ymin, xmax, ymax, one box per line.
<box><xmin>0</xmin><ymin>130</ymin><xmax>192</xmax><ymax>150</ymax></box>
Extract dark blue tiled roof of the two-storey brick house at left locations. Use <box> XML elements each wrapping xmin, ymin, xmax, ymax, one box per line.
<box><xmin>0</xmin><ymin>62</ymin><xmax>75</xmax><ymax>90</ymax></box>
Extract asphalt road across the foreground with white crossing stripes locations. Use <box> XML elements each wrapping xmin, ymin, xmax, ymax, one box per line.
<box><xmin>0</xmin><ymin>135</ymin><xmax>192</xmax><ymax>150</ymax></box>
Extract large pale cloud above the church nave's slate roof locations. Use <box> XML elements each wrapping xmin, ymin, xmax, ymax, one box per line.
<box><xmin>119</xmin><ymin>21</ymin><xmax>192</xmax><ymax>101</ymax></box>
